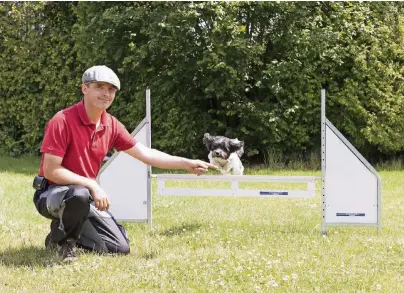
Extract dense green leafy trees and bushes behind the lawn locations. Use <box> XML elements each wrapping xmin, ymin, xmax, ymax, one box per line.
<box><xmin>0</xmin><ymin>2</ymin><xmax>404</xmax><ymax>162</ymax></box>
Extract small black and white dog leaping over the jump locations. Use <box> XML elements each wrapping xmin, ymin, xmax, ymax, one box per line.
<box><xmin>203</xmin><ymin>133</ymin><xmax>244</xmax><ymax>175</ymax></box>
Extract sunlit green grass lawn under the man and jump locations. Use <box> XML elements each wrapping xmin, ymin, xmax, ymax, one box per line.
<box><xmin>0</xmin><ymin>157</ymin><xmax>404</xmax><ymax>292</ymax></box>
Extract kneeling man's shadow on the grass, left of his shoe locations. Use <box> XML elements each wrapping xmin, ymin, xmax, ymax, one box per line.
<box><xmin>0</xmin><ymin>246</ymin><xmax>60</xmax><ymax>267</ymax></box>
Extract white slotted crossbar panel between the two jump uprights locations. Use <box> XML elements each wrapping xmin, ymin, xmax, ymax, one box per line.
<box><xmin>153</xmin><ymin>174</ymin><xmax>321</xmax><ymax>198</ymax></box>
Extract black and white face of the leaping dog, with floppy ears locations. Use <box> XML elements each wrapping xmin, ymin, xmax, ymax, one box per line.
<box><xmin>203</xmin><ymin>133</ymin><xmax>244</xmax><ymax>160</ymax></box>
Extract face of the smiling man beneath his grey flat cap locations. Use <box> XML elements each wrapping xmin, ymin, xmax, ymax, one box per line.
<box><xmin>81</xmin><ymin>82</ymin><xmax>117</xmax><ymax>110</ymax></box>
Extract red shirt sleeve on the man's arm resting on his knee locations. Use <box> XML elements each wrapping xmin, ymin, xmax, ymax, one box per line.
<box><xmin>41</xmin><ymin>112</ymin><xmax>68</xmax><ymax>157</ymax></box>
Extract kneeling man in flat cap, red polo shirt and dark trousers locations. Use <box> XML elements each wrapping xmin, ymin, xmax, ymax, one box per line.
<box><xmin>34</xmin><ymin>66</ymin><xmax>216</xmax><ymax>261</ymax></box>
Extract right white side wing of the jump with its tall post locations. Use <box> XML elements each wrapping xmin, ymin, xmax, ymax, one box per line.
<box><xmin>321</xmin><ymin>89</ymin><xmax>381</xmax><ymax>233</ymax></box>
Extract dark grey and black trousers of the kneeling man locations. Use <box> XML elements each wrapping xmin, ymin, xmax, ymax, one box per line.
<box><xmin>34</xmin><ymin>185</ymin><xmax>130</xmax><ymax>254</ymax></box>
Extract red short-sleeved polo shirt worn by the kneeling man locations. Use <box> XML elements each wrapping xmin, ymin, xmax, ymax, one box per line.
<box><xmin>39</xmin><ymin>101</ymin><xmax>136</xmax><ymax>184</ymax></box>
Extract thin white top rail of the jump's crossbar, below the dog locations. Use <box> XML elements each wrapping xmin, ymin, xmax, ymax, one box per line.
<box><xmin>152</xmin><ymin>174</ymin><xmax>321</xmax><ymax>182</ymax></box>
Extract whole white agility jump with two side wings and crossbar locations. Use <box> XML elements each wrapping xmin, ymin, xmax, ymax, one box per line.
<box><xmin>97</xmin><ymin>89</ymin><xmax>381</xmax><ymax>233</ymax></box>
